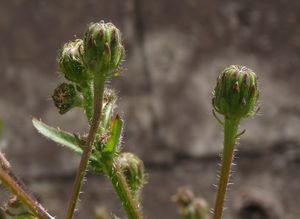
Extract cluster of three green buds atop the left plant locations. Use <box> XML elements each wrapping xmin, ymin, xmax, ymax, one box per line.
<box><xmin>52</xmin><ymin>21</ymin><xmax>125</xmax><ymax>116</ymax></box>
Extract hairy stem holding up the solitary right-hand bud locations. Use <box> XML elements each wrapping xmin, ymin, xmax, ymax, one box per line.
<box><xmin>213</xmin><ymin>118</ymin><xmax>240</xmax><ymax>219</ymax></box>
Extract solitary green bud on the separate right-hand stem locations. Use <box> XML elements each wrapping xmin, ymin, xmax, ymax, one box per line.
<box><xmin>212</xmin><ymin>65</ymin><xmax>259</xmax><ymax>119</ymax></box>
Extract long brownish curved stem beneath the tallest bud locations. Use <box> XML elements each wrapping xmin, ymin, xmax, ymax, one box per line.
<box><xmin>66</xmin><ymin>78</ymin><xmax>105</xmax><ymax>219</ymax></box>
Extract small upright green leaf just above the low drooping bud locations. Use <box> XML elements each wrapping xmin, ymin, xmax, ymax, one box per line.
<box><xmin>104</xmin><ymin>116</ymin><xmax>123</xmax><ymax>153</ymax></box>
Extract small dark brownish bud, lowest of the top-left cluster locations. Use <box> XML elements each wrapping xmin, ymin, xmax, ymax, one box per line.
<box><xmin>52</xmin><ymin>83</ymin><xmax>83</xmax><ymax>114</ymax></box>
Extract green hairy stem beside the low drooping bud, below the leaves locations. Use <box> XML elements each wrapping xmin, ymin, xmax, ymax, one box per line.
<box><xmin>106</xmin><ymin>159</ymin><xmax>144</xmax><ymax>219</ymax></box>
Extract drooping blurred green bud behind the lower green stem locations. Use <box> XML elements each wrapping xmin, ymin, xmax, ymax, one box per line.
<box><xmin>118</xmin><ymin>153</ymin><xmax>146</xmax><ymax>193</ymax></box>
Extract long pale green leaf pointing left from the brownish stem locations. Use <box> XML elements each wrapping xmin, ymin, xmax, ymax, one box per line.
<box><xmin>32</xmin><ymin>118</ymin><xmax>82</xmax><ymax>154</ymax></box>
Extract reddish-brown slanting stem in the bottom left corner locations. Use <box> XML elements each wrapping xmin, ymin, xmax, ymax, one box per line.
<box><xmin>0</xmin><ymin>154</ymin><xmax>54</xmax><ymax>219</ymax></box>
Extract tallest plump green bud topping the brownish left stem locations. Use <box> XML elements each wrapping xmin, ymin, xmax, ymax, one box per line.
<box><xmin>83</xmin><ymin>21</ymin><xmax>124</xmax><ymax>77</ymax></box>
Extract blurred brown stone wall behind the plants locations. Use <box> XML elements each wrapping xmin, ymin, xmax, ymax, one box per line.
<box><xmin>0</xmin><ymin>0</ymin><xmax>300</xmax><ymax>219</ymax></box>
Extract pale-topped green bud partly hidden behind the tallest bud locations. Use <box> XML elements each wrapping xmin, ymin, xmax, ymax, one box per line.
<box><xmin>59</xmin><ymin>39</ymin><xmax>89</xmax><ymax>84</ymax></box>
